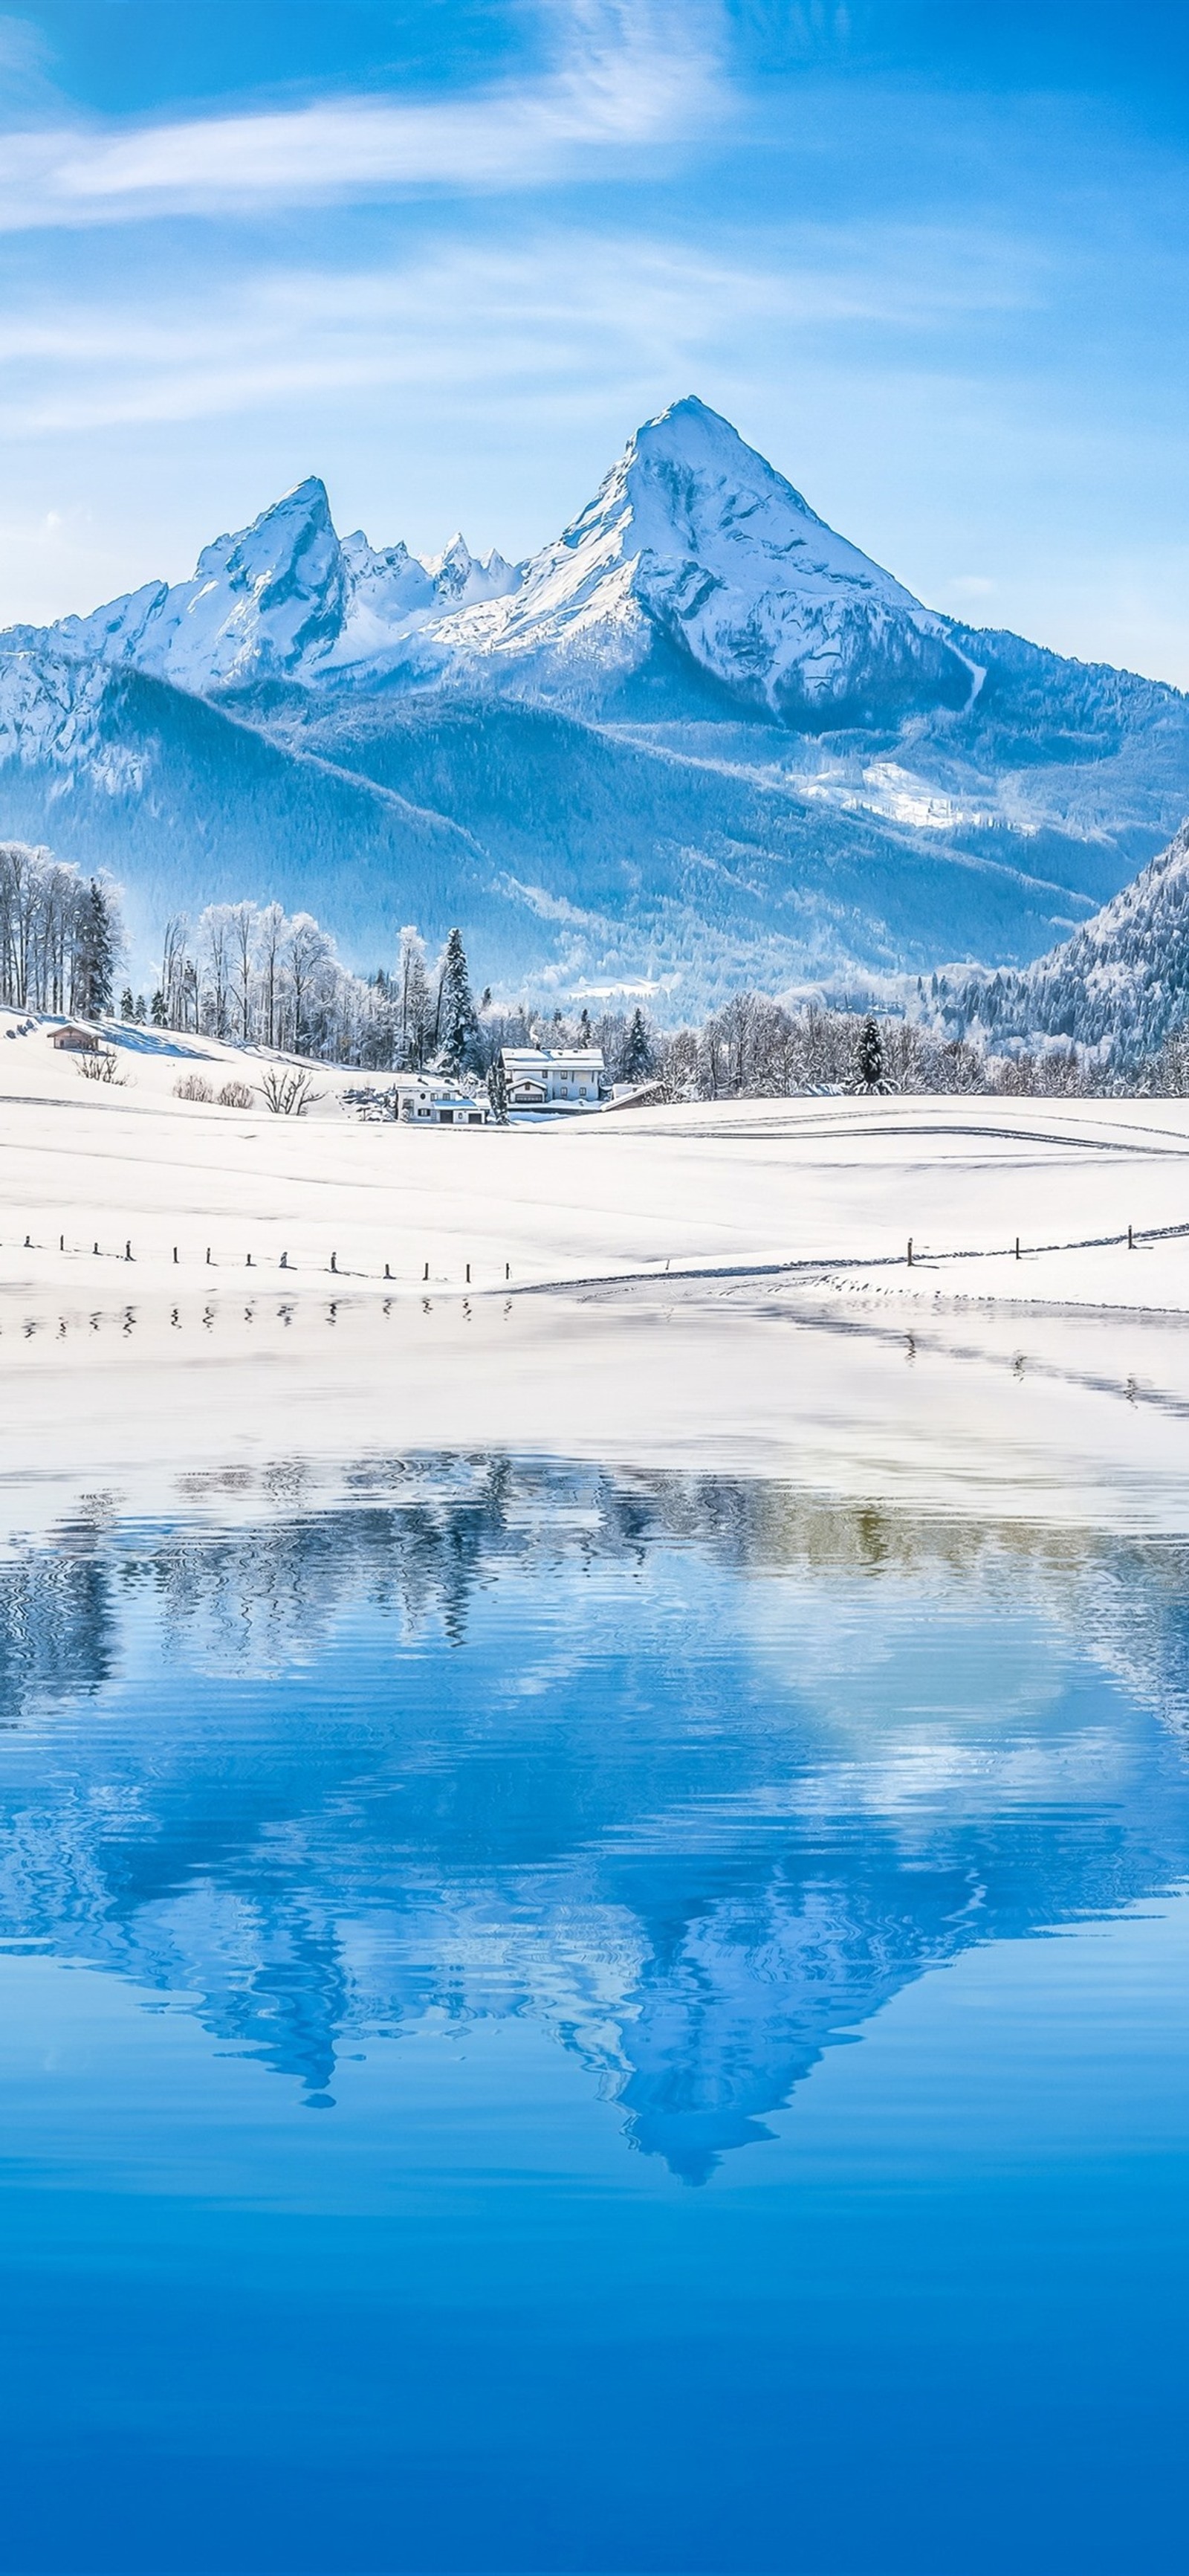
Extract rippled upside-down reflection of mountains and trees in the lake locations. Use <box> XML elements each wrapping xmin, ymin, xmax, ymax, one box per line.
<box><xmin>0</xmin><ymin>1458</ymin><xmax>1189</xmax><ymax>2182</ymax></box>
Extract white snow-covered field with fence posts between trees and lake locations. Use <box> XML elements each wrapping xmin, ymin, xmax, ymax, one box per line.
<box><xmin>0</xmin><ymin>1013</ymin><xmax>1189</xmax><ymax>1528</ymax></box>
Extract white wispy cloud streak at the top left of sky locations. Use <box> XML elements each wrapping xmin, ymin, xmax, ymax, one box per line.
<box><xmin>0</xmin><ymin>0</ymin><xmax>728</xmax><ymax>232</ymax></box>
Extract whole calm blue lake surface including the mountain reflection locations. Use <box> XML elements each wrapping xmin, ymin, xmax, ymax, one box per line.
<box><xmin>0</xmin><ymin>1458</ymin><xmax>1189</xmax><ymax>2576</ymax></box>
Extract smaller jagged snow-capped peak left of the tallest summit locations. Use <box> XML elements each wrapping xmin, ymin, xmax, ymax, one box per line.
<box><xmin>21</xmin><ymin>474</ymin><xmax>517</xmax><ymax>696</ymax></box>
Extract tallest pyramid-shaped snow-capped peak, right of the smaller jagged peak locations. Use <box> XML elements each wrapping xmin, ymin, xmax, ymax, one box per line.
<box><xmin>427</xmin><ymin>397</ymin><xmax>983</xmax><ymax>729</ymax></box>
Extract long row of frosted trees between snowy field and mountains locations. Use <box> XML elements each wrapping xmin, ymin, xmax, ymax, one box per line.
<box><xmin>0</xmin><ymin>842</ymin><xmax>1189</xmax><ymax>1100</ymax></box>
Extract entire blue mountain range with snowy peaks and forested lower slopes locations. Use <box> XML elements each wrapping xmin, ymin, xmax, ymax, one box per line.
<box><xmin>0</xmin><ymin>399</ymin><xmax>1189</xmax><ymax>1015</ymax></box>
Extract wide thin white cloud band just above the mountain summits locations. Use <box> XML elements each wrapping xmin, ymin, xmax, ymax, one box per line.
<box><xmin>0</xmin><ymin>227</ymin><xmax>1040</xmax><ymax>438</ymax></box>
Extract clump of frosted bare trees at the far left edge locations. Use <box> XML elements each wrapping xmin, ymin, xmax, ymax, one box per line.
<box><xmin>0</xmin><ymin>840</ymin><xmax>123</xmax><ymax>1020</ymax></box>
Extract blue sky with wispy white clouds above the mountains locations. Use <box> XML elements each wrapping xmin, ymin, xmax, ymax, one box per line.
<box><xmin>0</xmin><ymin>0</ymin><xmax>1189</xmax><ymax>685</ymax></box>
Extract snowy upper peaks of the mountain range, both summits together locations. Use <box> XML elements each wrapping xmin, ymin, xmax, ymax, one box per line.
<box><xmin>21</xmin><ymin>397</ymin><xmax>983</xmax><ymax>729</ymax></box>
